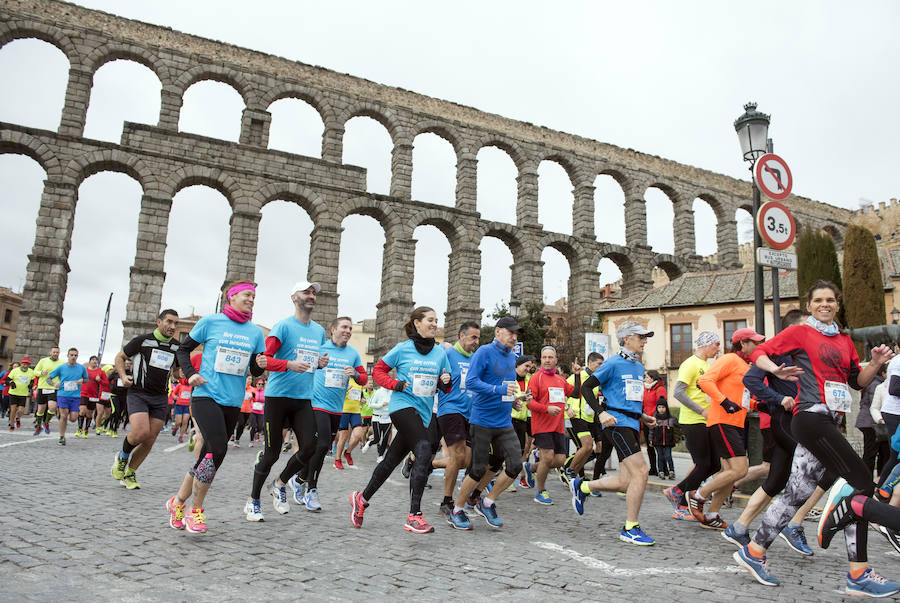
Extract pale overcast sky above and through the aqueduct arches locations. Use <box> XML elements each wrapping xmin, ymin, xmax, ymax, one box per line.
<box><xmin>0</xmin><ymin>0</ymin><xmax>900</xmax><ymax>357</ymax></box>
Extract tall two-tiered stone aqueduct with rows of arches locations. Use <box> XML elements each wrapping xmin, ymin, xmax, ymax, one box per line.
<box><xmin>0</xmin><ymin>0</ymin><xmax>850</xmax><ymax>364</ymax></box>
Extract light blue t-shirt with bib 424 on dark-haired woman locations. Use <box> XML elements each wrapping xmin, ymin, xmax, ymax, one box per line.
<box><xmin>381</xmin><ymin>339</ymin><xmax>450</xmax><ymax>427</ymax></box>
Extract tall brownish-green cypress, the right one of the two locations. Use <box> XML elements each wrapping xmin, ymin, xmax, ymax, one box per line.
<box><xmin>841</xmin><ymin>224</ymin><xmax>885</xmax><ymax>329</ymax></box>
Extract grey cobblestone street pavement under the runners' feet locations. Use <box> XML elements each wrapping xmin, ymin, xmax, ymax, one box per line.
<box><xmin>0</xmin><ymin>428</ymin><xmax>900</xmax><ymax>601</ymax></box>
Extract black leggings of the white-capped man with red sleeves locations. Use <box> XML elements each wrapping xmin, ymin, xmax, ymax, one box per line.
<box><xmin>250</xmin><ymin>396</ymin><xmax>316</xmax><ymax>499</ymax></box>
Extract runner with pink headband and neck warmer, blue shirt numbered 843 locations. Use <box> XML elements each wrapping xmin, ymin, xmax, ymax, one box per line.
<box><xmin>169</xmin><ymin>281</ymin><xmax>268</xmax><ymax>534</ymax></box>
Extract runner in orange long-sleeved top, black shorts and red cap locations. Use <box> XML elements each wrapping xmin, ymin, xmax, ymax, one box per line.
<box><xmin>684</xmin><ymin>328</ymin><xmax>765</xmax><ymax>530</ymax></box>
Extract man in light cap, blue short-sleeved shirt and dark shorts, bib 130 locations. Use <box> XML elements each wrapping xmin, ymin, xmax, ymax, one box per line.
<box><xmin>570</xmin><ymin>321</ymin><xmax>656</xmax><ymax>546</ymax></box>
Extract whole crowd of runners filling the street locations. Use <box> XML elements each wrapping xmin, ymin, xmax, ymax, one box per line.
<box><xmin>0</xmin><ymin>281</ymin><xmax>900</xmax><ymax>597</ymax></box>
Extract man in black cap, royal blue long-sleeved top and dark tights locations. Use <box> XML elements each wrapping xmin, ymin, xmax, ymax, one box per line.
<box><xmin>447</xmin><ymin>316</ymin><xmax>528</xmax><ymax>530</ymax></box>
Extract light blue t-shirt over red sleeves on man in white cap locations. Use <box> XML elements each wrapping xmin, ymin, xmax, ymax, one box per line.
<box><xmin>266</xmin><ymin>316</ymin><xmax>326</xmax><ymax>400</ymax></box>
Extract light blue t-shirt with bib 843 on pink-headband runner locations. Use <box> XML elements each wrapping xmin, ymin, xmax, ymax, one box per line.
<box><xmin>190</xmin><ymin>313</ymin><xmax>269</xmax><ymax>406</ymax></box>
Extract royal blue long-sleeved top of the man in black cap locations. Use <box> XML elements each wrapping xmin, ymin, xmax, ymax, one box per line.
<box><xmin>466</xmin><ymin>339</ymin><xmax>516</xmax><ymax>429</ymax></box>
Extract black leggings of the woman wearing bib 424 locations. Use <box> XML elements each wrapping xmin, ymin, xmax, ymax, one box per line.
<box><xmin>363</xmin><ymin>407</ymin><xmax>431</xmax><ymax>514</ymax></box>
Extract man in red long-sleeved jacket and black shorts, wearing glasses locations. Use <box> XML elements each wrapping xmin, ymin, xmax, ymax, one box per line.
<box><xmin>528</xmin><ymin>345</ymin><xmax>581</xmax><ymax>505</ymax></box>
